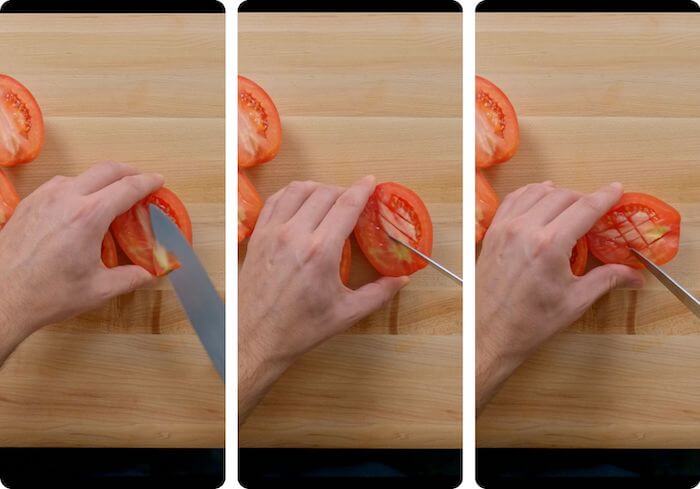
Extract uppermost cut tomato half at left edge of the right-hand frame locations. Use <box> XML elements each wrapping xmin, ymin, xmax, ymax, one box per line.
<box><xmin>475</xmin><ymin>76</ymin><xmax>520</xmax><ymax>168</ymax></box>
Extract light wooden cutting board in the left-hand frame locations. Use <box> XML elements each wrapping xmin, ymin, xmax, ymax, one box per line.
<box><xmin>0</xmin><ymin>14</ymin><xmax>225</xmax><ymax>447</ymax></box>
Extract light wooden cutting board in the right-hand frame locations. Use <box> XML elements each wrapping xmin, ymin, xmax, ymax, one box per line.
<box><xmin>476</xmin><ymin>14</ymin><xmax>700</xmax><ymax>448</ymax></box>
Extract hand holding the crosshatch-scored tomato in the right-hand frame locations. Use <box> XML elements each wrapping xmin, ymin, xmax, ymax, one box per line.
<box><xmin>476</xmin><ymin>182</ymin><xmax>644</xmax><ymax>412</ymax></box>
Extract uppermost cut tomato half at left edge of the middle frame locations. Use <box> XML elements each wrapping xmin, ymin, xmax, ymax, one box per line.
<box><xmin>238</xmin><ymin>76</ymin><xmax>282</xmax><ymax>168</ymax></box>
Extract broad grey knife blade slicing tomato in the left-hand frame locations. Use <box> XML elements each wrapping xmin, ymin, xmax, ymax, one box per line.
<box><xmin>148</xmin><ymin>204</ymin><xmax>226</xmax><ymax>382</ymax></box>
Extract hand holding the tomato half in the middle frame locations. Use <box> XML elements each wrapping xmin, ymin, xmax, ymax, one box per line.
<box><xmin>238</xmin><ymin>177</ymin><xmax>408</xmax><ymax>420</ymax></box>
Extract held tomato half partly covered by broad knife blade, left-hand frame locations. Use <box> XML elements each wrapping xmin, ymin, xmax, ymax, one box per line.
<box><xmin>111</xmin><ymin>187</ymin><xmax>192</xmax><ymax>277</ymax></box>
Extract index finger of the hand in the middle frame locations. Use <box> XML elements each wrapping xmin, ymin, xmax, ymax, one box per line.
<box><xmin>316</xmin><ymin>175</ymin><xmax>376</xmax><ymax>244</ymax></box>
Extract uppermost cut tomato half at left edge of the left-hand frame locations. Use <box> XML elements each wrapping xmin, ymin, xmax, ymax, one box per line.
<box><xmin>0</xmin><ymin>75</ymin><xmax>44</xmax><ymax>166</ymax></box>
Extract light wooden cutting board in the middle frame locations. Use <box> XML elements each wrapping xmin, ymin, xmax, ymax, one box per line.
<box><xmin>239</xmin><ymin>14</ymin><xmax>462</xmax><ymax>448</ymax></box>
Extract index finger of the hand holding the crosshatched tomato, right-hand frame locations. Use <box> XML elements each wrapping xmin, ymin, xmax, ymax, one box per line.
<box><xmin>546</xmin><ymin>182</ymin><xmax>622</xmax><ymax>243</ymax></box>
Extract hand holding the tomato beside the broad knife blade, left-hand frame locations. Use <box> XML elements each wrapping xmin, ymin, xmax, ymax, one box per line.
<box><xmin>0</xmin><ymin>162</ymin><xmax>163</xmax><ymax>362</ymax></box>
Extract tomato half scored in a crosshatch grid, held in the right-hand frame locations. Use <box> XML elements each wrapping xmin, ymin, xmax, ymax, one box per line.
<box><xmin>586</xmin><ymin>193</ymin><xmax>681</xmax><ymax>268</ymax></box>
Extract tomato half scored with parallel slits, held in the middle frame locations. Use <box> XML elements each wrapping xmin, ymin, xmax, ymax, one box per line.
<box><xmin>354</xmin><ymin>182</ymin><xmax>433</xmax><ymax>277</ymax></box>
